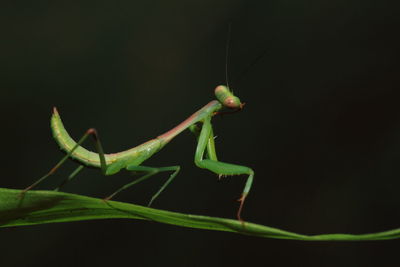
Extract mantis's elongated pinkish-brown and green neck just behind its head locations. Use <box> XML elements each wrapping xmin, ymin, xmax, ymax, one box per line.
<box><xmin>157</xmin><ymin>100</ymin><xmax>222</xmax><ymax>146</ymax></box>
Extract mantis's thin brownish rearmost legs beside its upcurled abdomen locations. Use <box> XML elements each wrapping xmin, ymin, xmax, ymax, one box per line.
<box><xmin>21</xmin><ymin>128</ymin><xmax>107</xmax><ymax>194</ymax></box>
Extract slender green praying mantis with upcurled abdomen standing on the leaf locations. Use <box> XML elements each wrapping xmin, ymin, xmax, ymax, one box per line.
<box><xmin>22</xmin><ymin>85</ymin><xmax>254</xmax><ymax>221</ymax></box>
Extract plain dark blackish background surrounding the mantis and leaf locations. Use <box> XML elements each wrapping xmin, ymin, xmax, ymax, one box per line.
<box><xmin>0</xmin><ymin>0</ymin><xmax>400</xmax><ymax>266</ymax></box>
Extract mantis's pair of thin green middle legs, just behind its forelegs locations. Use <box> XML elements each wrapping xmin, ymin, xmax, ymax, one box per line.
<box><xmin>105</xmin><ymin>165</ymin><xmax>181</xmax><ymax>206</ymax></box>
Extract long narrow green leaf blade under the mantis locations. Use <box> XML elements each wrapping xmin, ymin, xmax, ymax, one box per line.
<box><xmin>0</xmin><ymin>188</ymin><xmax>400</xmax><ymax>241</ymax></box>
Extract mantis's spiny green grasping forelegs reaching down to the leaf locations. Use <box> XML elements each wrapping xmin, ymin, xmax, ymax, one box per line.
<box><xmin>194</xmin><ymin>117</ymin><xmax>254</xmax><ymax>221</ymax></box>
